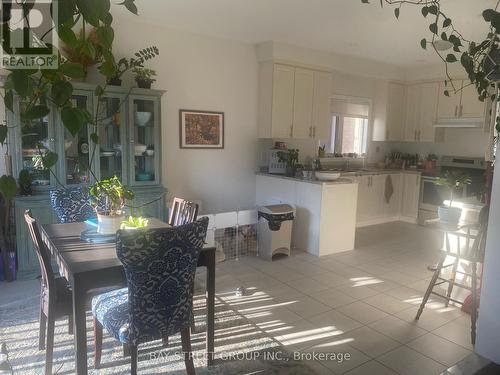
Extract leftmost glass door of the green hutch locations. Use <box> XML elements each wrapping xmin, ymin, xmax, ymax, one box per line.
<box><xmin>15</xmin><ymin>103</ymin><xmax>55</xmax><ymax>187</ymax></box>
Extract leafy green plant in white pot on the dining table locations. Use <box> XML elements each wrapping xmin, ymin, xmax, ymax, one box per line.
<box><xmin>90</xmin><ymin>176</ymin><xmax>135</xmax><ymax>234</ymax></box>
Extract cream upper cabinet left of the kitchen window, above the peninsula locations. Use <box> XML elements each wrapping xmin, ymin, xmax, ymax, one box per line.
<box><xmin>259</xmin><ymin>62</ymin><xmax>331</xmax><ymax>138</ymax></box>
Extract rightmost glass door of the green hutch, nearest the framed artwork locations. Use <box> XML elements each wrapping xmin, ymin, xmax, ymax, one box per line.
<box><xmin>129</xmin><ymin>96</ymin><xmax>160</xmax><ymax>185</ymax></box>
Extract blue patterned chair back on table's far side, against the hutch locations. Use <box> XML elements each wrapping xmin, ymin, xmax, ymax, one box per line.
<box><xmin>50</xmin><ymin>187</ymin><xmax>96</xmax><ymax>223</ymax></box>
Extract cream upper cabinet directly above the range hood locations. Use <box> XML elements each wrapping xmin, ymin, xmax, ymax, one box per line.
<box><xmin>437</xmin><ymin>80</ymin><xmax>486</xmax><ymax>125</ymax></box>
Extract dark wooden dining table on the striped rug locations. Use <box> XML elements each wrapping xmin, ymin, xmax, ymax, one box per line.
<box><xmin>40</xmin><ymin>218</ymin><xmax>215</xmax><ymax>375</ymax></box>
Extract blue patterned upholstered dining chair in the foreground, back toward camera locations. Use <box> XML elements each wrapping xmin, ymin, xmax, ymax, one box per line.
<box><xmin>92</xmin><ymin>218</ymin><xmax>208</xmax><ymax>375</ymax></box>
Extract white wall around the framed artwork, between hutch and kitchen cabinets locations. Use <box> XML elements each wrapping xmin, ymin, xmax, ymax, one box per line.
<box><xmin>113</xmin><ymin>7</ymin><xmax>257</xmax><ymax>212</ymax></box>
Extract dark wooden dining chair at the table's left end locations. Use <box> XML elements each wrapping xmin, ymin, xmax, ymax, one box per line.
<box><xmin>24</xmin><ymin>210</ymin><xmax>73</xmax><ymax>375</ymax></box>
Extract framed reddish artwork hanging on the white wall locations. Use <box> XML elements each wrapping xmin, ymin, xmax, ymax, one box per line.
<box><xmin>179</xmin><ymin>109</ymin><xmax>224</xmax><ymax>149</ymax></box>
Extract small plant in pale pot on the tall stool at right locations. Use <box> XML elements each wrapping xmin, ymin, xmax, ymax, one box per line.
<box><xmin>434</xmin><ymin>171</ymin><xmax>472</xmax><ymax>225</ymax></box>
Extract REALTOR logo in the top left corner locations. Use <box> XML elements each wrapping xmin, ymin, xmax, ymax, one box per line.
<box><xmin>0</xmin><ymin>0</ymin><xmax>59</xmax><ymax>69</ymax></box>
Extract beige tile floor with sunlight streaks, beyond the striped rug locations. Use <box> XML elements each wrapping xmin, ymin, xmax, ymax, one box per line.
<box><xmin>212</xmin><ymin>223</ymin><xmax>472</xmax><ymax>375</ymax></box>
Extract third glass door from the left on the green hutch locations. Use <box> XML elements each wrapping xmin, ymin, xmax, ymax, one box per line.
<box><xmin>96</xmin><ymin>96</ymin><xmax>126</xmax><ymax>181</ymax></box>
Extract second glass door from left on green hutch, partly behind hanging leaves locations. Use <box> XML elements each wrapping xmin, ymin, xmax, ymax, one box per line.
<box><xmin>61</xmin><ymin>94</ymin><xmax>92</xmax><ymax>185</ymax></box>
